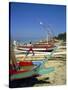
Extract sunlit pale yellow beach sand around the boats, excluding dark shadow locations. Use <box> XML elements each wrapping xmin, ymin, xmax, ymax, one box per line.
<box><xmin>12</xmin><ymin>45</ymin><xmax>66</xmax><ymax>87</ymax></box>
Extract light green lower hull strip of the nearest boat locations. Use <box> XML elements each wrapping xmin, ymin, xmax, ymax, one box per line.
<box><xmin>10</xmin><ymin>67</ymin><xmax>54</xmax><ymax>80</ymax></box>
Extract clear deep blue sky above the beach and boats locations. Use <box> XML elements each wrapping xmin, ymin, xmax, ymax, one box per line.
<box><xmin>9</xmin><ymin>2</ymin><xmax>66</xmax><ymax>40</ymax></box>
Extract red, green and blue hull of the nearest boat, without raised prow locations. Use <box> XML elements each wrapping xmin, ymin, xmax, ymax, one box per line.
<box><xmin>10</xmin><ymin>61</ymin><xmax>54</xmax><ymax>80</ymax></box>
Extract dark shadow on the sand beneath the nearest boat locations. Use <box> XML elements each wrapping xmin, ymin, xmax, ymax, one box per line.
<box><xmin>9</xmin><ymin>77</ymin><xmax>50</xmax><ymax>88</ymax></box>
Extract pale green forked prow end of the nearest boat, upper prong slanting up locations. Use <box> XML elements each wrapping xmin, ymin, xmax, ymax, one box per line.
<box><xmin>33</xmin><ymin>42</ymin><xmax>61</xmax><ymax>74</ymax></box>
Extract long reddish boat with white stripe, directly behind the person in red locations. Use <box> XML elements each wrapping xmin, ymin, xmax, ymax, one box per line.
<box><xmin>17</xmin><ymin>44</ymin><xmax>54</xmax><ymax>52</ymax></box>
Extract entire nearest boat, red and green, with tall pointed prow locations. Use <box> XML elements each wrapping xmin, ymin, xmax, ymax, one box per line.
<box><xmin>9</xmin><ymin>41</ymin><xmax>57</xmax><ymax>80</ymax></box>
